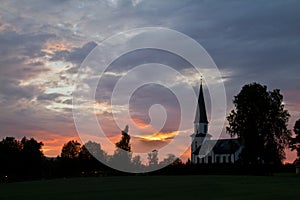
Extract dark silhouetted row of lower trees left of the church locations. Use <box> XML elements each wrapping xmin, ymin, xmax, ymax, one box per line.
<box><xmin>0</xmin><ymin>127</ymin><xmax>184</xmax><ymax>181</ymax></box>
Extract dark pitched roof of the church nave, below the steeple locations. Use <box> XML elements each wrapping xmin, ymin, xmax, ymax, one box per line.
<box><xmin>193</xmin><ymin>139</ymin><xmax>241</xmax><ymax>155</ymax></box>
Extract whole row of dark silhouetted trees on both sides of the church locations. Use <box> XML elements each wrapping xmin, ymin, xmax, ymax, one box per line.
<box><xmin>0</xmin><ymin>83</ymin><xmax>300</xmax><ymax>181</ymax></box>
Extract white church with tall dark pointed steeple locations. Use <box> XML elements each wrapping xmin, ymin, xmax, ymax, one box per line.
<box><xmin>191</xmin><ymin>80</ymin><xmax>242</xmax><ymax>164</ymax></box>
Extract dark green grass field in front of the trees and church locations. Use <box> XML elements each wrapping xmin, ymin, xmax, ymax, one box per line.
<box><xmin>0</xmin><ymin>175</ymin><xmax>300</xmax><ymax>200</ymax></box>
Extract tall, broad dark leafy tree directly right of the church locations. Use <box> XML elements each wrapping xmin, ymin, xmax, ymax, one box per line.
<box><xmin>226</xmin><ymin>83</ymin><xmax>291</xmax><ymax>164</ymax></box>
